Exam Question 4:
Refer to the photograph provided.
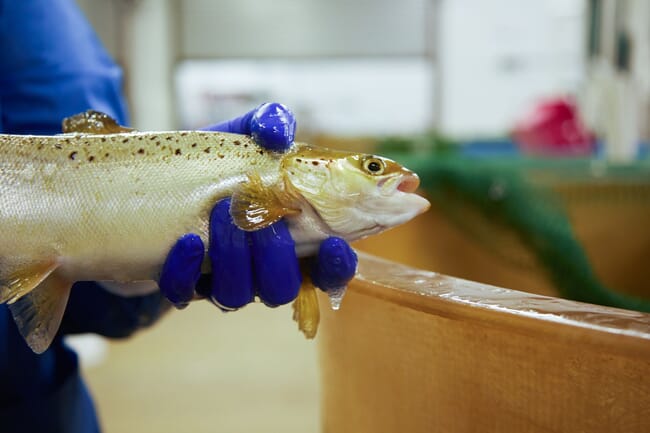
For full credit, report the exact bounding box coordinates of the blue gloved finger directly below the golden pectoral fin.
[250,220,302,307]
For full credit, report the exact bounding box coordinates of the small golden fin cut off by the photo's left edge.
[0,260,58,304]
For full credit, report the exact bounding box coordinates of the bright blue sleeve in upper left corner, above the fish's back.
[0,0,127,134]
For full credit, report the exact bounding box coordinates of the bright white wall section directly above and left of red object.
[440,0,584,135]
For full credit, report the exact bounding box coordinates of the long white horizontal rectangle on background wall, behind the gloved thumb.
[176,57,433,136]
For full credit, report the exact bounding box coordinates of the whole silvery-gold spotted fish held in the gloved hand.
[0,110,429,353]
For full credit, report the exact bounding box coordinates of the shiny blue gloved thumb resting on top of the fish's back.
[202,102,296,152]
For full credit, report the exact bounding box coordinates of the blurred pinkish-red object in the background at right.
[512,98,596,156]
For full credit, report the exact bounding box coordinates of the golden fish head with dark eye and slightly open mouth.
[282,145,430,241]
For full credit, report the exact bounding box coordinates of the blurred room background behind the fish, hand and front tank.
[69,0,650,432]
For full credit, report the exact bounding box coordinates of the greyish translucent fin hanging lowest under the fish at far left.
[9,272,72,353]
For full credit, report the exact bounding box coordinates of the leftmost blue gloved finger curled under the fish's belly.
[158,233,204,308]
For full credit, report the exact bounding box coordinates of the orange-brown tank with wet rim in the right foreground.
[319,255,650,433]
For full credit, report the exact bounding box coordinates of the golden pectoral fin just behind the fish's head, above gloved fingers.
[230,173,300,231]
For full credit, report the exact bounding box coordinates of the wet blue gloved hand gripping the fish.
[159,103,357,310]
